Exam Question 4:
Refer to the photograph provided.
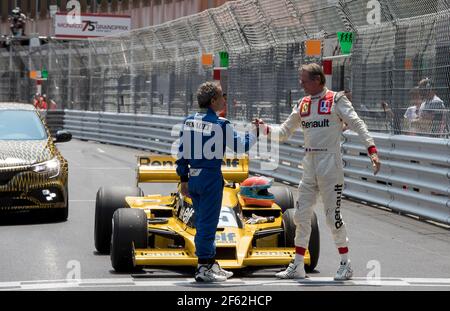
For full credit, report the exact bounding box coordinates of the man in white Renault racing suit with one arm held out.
[255,64,380,280]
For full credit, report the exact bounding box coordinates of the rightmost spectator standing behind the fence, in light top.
[418,78,446,137]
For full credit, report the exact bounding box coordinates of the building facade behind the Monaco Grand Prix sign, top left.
[0,0,227,36]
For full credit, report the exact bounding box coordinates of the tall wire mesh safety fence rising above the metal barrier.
[0,0,450,137]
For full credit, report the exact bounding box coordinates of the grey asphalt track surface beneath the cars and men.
[0,140,450,293]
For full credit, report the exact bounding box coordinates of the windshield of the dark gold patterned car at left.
[0,110,47,140]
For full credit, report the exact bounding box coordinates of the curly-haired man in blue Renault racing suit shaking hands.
[176,82,257,282]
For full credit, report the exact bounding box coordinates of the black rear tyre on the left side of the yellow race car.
[94,186,144,254]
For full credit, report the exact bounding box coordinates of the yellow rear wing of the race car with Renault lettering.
[137,155,248,184]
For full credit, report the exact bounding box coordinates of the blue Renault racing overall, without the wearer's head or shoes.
[176,108,256,260]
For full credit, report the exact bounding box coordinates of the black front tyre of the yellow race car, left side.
[111,208,148,272]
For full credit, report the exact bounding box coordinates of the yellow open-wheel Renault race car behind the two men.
[94,156,320,272]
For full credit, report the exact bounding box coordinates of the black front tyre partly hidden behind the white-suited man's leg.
[280,209,320,272]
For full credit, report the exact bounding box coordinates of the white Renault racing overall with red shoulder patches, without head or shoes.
[270,88,376,252]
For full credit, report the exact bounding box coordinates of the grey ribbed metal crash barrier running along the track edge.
[48,110,450,224]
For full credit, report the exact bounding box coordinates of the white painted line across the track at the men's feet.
[0,277,450,291]
